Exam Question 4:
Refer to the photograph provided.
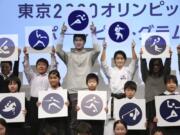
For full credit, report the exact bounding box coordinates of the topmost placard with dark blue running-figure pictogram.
[65,7,92,34]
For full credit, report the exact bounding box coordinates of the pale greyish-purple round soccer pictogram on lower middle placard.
[81,94,103,116]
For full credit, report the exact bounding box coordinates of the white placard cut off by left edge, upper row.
[0,34,18,61]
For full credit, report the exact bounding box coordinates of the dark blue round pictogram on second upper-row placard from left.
[28,29,49,50]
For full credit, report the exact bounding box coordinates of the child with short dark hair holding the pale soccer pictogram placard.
[77,73,107,135]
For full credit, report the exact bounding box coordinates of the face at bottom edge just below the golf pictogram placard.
[114,123,127,135]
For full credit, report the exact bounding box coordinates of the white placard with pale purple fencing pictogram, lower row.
[38,89,68,118]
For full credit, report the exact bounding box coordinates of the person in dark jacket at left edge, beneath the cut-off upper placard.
[0,49,21,93]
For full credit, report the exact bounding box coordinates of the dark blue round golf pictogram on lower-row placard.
[119,103,142,126]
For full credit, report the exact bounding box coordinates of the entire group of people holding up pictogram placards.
[0,24,180,135]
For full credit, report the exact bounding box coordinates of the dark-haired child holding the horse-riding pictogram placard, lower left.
[7,76,27,135]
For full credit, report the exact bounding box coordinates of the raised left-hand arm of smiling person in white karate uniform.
[101,41,110,78]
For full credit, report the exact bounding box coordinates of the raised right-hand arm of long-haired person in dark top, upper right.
[163,50,172,76]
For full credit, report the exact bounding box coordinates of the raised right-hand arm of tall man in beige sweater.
[90,23,100,65]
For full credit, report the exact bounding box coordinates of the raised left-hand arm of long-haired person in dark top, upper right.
[140,49,149,83]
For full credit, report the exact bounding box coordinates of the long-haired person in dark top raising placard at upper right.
[140,50,172,132]
